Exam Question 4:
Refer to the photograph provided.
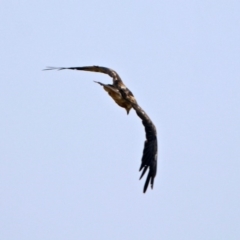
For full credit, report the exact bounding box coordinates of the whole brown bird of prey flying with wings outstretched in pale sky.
[44,66,157,193]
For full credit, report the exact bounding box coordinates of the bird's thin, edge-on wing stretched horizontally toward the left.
[44,66,122,82]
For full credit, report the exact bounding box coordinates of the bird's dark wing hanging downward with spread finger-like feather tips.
[133,104,157,193]
